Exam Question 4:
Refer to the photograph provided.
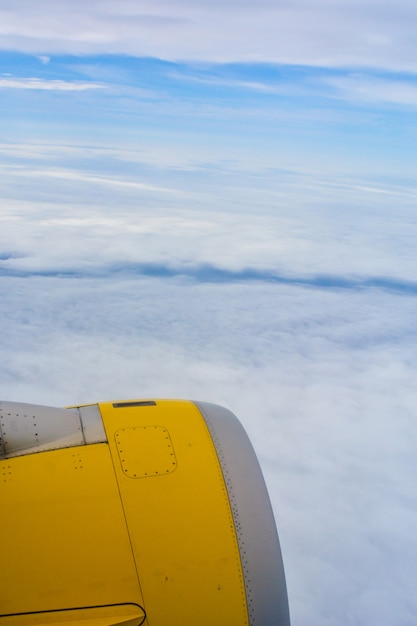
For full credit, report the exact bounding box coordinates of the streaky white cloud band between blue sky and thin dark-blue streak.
[0,144,417,282]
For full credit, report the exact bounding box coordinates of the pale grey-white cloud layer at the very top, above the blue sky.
[0,0,415,71]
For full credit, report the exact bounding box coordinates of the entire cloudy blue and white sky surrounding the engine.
[0,0,417,626]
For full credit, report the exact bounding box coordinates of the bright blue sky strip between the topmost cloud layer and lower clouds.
[0,52,417,176]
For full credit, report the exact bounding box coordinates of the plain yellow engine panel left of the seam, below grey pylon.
[0,443,143,626]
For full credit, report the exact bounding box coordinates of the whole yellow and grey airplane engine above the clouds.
[0,399,290,626]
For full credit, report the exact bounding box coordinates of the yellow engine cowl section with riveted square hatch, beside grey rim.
[99,401,249,626]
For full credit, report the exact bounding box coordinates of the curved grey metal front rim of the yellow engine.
[194,402,290,626]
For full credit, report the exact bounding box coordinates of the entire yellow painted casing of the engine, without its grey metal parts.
[0,401,249,626]
